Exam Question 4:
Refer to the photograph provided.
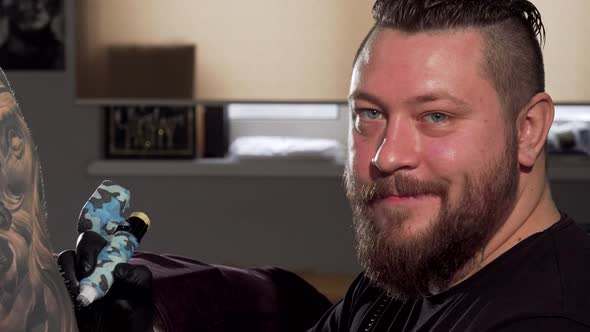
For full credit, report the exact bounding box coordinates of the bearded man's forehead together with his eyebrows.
[349,25,498,113]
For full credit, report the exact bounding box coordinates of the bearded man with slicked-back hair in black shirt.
[314,0,590,331]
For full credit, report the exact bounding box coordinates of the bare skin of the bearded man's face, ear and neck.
[348,28,559,282]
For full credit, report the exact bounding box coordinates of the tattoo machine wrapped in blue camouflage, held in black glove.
[77,180,150,306]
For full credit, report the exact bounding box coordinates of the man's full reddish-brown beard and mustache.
[344,137,518,299]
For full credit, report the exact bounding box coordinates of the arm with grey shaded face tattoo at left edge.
[0,69,77,332]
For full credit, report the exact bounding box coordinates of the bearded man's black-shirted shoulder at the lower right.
[430,218,590,331]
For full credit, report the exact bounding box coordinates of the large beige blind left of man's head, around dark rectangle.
[77,0,372,100]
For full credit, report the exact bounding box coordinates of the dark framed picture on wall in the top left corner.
[0,0,65,70]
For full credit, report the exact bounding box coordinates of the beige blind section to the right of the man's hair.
[533,0,590,103]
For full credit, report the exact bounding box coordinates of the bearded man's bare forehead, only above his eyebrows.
[351,28,483,93]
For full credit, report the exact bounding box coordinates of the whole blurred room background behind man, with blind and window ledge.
[0,0,590,298]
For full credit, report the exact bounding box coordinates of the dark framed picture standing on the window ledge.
[103,105,196,159]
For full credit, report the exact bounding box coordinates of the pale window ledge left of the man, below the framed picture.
[88,158,344,178]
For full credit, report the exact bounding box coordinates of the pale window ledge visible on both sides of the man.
[88,155,590,180]
